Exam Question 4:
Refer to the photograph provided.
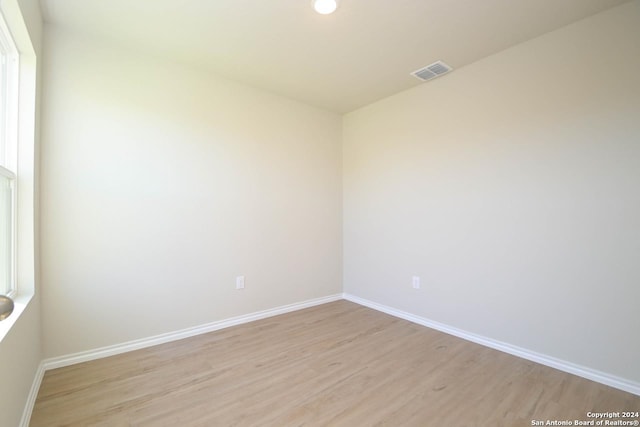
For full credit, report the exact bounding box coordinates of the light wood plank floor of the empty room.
[31,301,640,427]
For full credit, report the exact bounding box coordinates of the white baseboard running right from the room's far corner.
[343,293,640,396]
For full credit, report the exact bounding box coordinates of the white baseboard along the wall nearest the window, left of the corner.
[42,294,342,372]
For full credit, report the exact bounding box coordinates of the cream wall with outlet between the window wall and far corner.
[41,27,342,357]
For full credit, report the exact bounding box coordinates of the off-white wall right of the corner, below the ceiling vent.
[343,1,640,381]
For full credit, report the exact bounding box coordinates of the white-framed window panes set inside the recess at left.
[0,10,19,296]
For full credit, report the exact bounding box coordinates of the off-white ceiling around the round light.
[41,0,627,113]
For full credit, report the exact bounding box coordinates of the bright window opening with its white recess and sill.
[0,0,36,340]
